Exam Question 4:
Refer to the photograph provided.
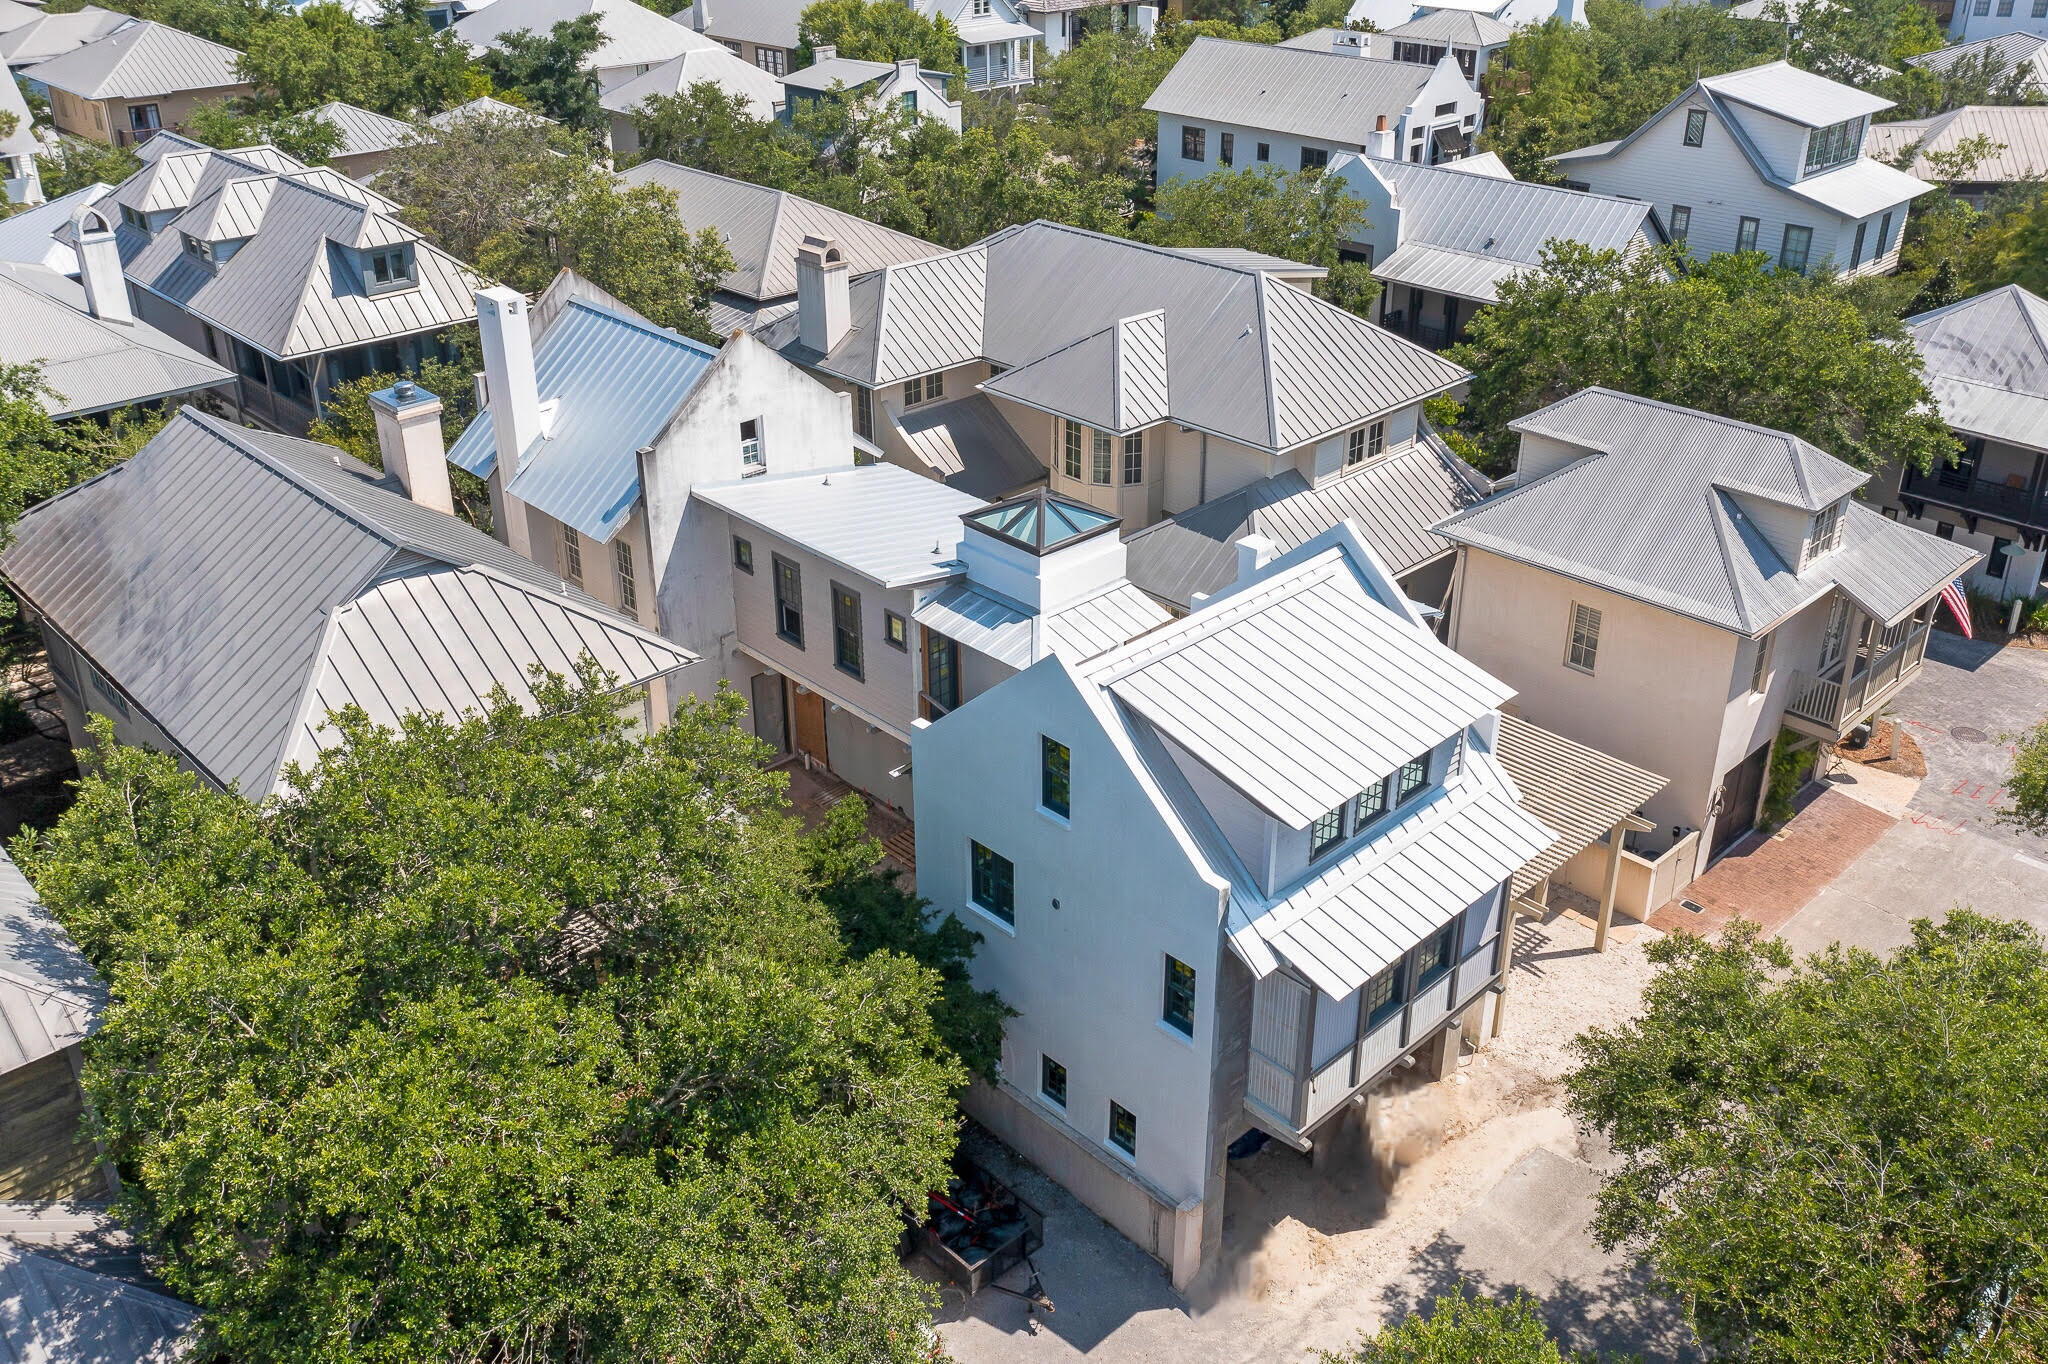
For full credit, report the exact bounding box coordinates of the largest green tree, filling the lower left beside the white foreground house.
[20,670,963,1364]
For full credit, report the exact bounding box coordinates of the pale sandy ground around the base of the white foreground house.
[940,897,1657,1364]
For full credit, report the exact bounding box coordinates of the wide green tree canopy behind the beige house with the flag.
[1446,242,1956,473]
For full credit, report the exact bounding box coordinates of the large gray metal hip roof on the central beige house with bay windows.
[762,219,1470,451]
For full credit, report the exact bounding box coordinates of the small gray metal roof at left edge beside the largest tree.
[0,848,106,1075]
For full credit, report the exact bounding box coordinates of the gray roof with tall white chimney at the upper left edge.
[0,207,236,420]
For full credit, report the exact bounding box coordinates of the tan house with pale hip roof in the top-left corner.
[27,18,254,147]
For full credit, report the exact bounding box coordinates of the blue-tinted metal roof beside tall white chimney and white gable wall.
[449,299,719,543]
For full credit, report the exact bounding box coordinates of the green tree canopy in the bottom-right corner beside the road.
[1567,909,2048,1364]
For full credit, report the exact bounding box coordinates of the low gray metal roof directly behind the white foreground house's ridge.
[1124,440,1487,608]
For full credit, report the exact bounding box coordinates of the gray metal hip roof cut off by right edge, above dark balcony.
[1907,285,2048,451]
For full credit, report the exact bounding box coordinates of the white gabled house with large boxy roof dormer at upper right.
[1550,61,1929,276]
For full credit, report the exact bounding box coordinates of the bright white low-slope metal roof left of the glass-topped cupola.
[690,465,981,588]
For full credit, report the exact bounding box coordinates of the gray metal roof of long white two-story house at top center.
[1145,37,1436,145]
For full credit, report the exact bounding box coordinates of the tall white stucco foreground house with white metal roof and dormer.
[911,524,1554,1290]
